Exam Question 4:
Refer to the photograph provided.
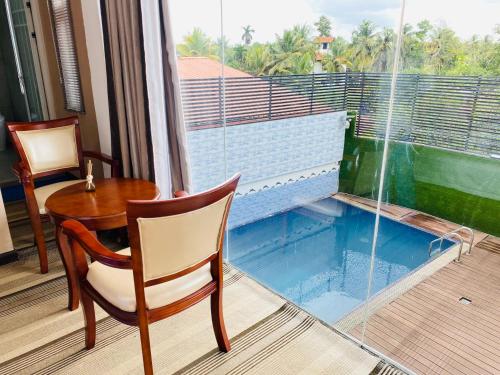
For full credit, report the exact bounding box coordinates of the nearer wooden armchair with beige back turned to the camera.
[62,175,240,374]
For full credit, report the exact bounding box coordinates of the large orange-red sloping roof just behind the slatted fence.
[177,57,330,130]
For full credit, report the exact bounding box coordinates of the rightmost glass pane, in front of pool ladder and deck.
[360,0,500,374]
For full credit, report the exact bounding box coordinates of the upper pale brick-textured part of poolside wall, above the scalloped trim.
[188,112,346,191]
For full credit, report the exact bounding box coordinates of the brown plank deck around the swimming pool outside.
[336,195,500,375]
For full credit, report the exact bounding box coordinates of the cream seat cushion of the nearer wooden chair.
[87,248,212,312]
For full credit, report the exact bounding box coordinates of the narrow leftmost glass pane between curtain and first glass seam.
[171,0,227,192]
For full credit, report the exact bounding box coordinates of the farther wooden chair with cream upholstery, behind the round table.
[7,117,119,273]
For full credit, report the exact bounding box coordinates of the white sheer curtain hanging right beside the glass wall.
[141,0,191,198]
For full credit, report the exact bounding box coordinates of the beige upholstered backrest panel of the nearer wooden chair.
[137,193,233,281]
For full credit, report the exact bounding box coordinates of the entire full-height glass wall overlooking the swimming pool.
[166,0,500,373]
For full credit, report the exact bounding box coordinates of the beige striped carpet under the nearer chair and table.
[0,267,379,375]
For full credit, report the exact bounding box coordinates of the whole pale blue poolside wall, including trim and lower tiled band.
[188,112,346,227]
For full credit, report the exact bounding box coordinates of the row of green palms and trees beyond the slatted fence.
[177,20,500,76]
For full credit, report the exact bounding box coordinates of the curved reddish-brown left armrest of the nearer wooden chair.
[61,220,132,269]
